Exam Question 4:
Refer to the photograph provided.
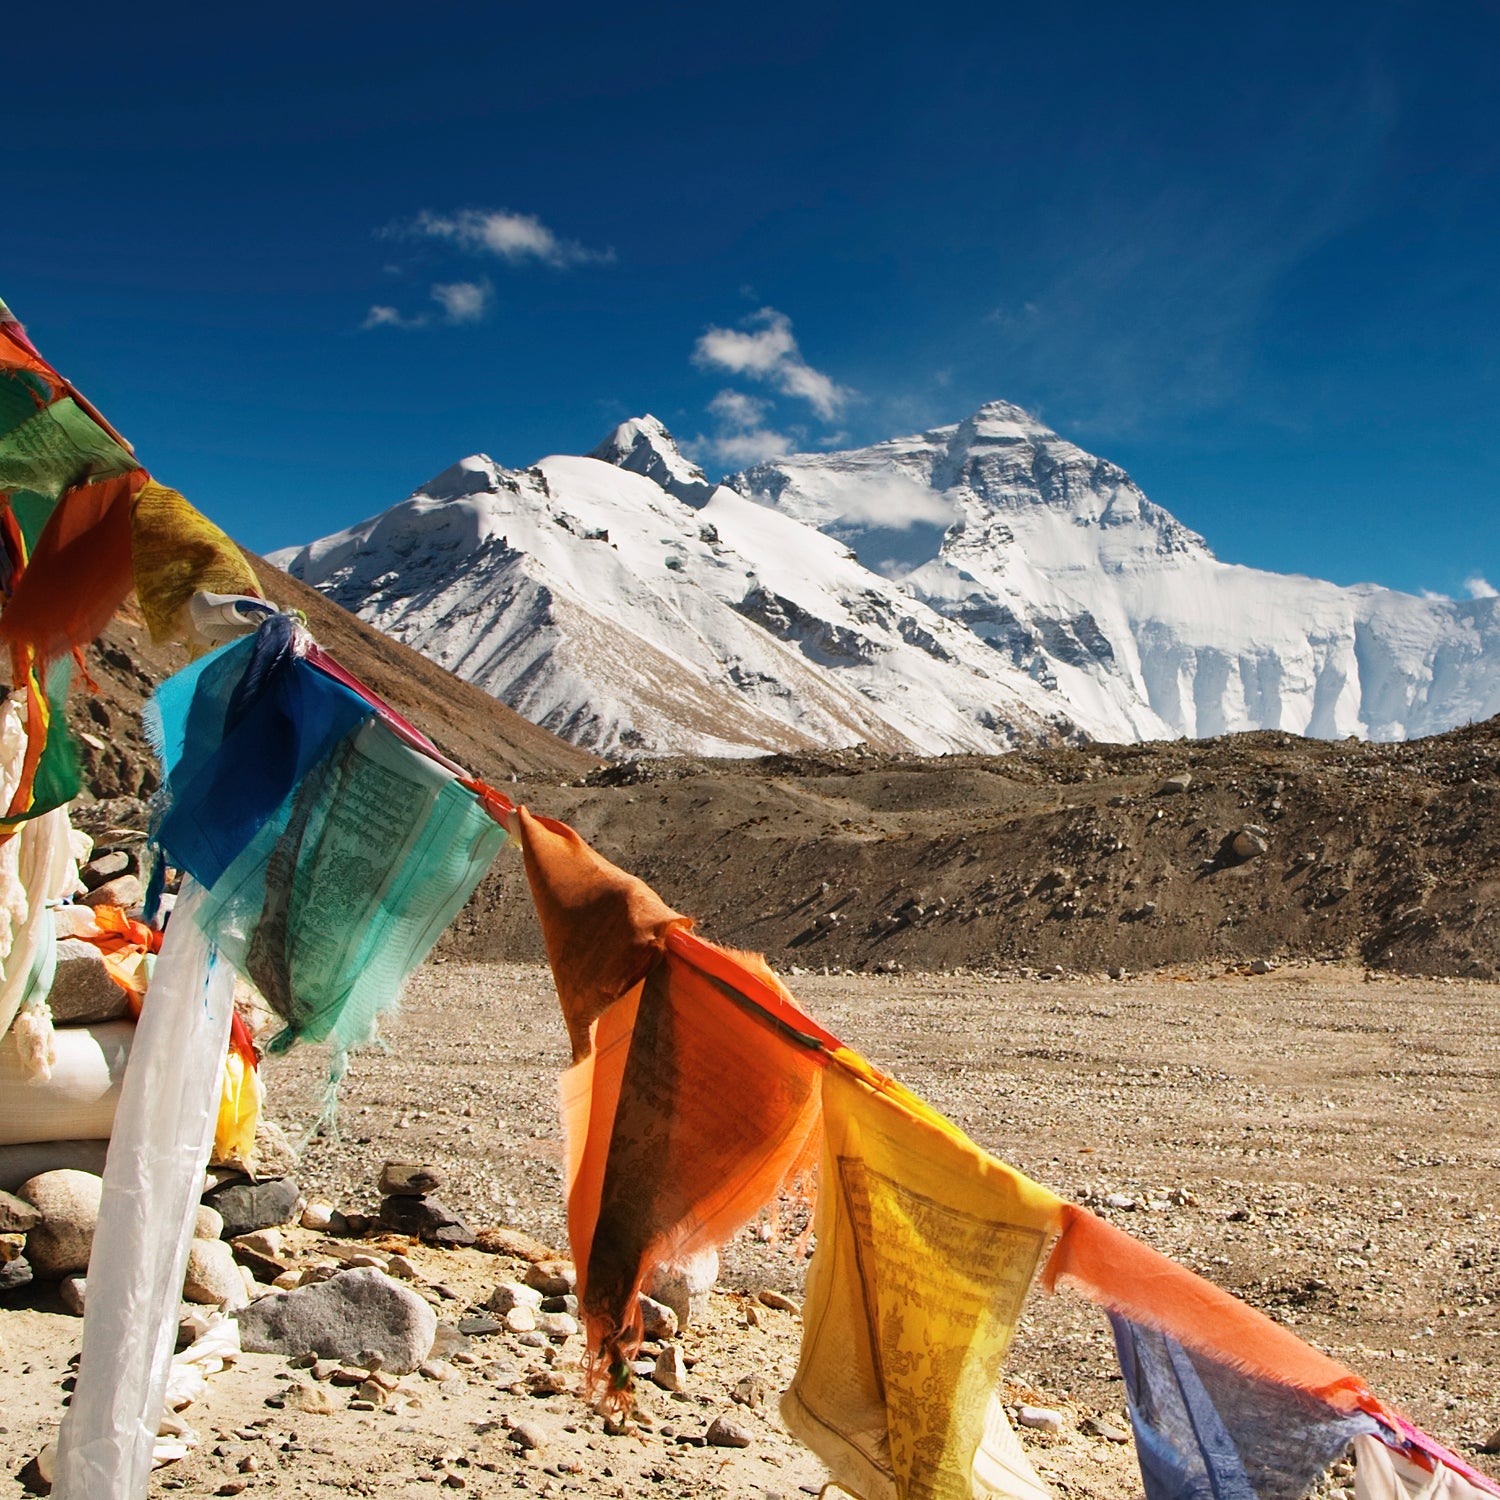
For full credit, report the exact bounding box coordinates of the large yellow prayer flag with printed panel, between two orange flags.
[782,1050,1062,1500]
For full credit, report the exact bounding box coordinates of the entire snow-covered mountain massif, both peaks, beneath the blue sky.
[272,402,1500,755]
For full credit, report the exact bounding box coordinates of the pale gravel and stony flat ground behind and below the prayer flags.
[0,962,1500,1500]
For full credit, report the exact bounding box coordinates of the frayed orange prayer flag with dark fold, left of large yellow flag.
[518,809,836,1404]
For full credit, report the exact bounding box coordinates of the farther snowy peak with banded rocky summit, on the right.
[726,402,1500,740]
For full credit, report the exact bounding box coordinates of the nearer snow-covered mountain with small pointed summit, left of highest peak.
[276,438,1073,755]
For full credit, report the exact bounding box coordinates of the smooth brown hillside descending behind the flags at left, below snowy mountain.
[68,557,599,822]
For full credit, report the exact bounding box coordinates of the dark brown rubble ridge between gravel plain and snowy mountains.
[447,720,1500,978]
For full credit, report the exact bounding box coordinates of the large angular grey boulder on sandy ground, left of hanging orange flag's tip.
[240,1269,435,1374]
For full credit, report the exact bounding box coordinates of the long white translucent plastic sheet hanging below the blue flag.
[53,881,234,1500]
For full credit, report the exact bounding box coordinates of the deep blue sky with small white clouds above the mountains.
[0,0,1500,594]
